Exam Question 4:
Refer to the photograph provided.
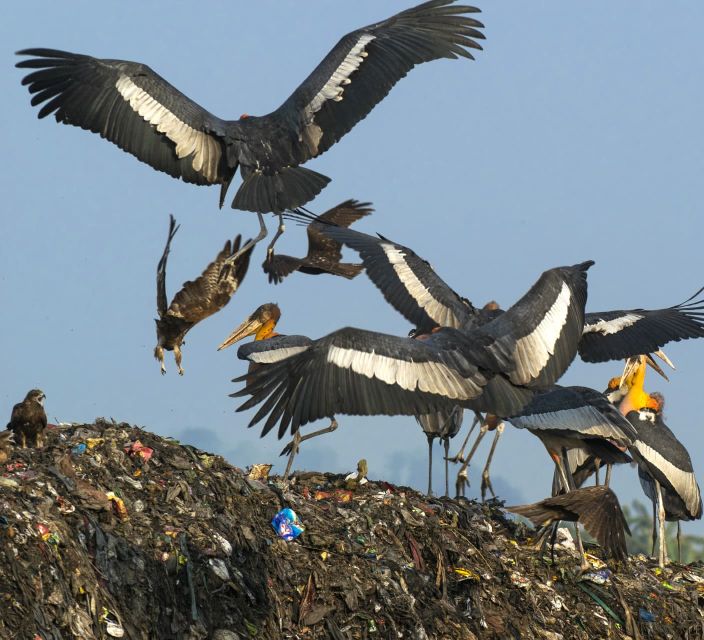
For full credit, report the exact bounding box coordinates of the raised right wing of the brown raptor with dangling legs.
[167,235,254,324]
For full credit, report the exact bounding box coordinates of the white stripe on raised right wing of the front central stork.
[511,282,571,384]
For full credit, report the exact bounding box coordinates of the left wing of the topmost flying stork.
[16,49,231,184]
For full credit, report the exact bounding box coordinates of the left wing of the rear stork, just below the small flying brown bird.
[321,226,476,331]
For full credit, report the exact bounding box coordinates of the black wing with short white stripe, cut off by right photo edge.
[579,288,704,362]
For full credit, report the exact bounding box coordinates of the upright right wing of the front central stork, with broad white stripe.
[470,261,594,389]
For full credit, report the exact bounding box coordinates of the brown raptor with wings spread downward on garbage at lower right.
[506,485,631,561]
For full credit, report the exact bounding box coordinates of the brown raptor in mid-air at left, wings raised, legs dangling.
[154,216,254,375]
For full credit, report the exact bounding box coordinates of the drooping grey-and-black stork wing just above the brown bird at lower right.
[507,386,637,445]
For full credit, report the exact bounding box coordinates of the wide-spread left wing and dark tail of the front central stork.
[232,328,532,437]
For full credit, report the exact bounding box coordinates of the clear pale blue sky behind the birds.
[0,0,704,533]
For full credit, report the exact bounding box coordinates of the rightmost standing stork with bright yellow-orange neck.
[619,358,702,566]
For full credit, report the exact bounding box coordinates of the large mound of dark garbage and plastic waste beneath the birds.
[0,420,704,640]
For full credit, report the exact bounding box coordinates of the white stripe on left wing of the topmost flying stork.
[115,75,221,182]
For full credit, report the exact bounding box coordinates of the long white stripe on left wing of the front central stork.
[327,345,482,400]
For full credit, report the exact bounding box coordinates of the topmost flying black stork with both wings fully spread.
[17,0,484,258]
